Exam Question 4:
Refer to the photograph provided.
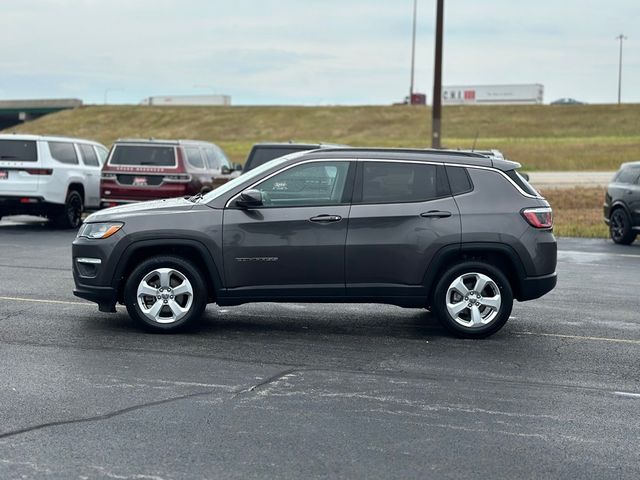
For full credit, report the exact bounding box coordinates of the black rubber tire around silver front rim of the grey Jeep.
[124,255,208,333]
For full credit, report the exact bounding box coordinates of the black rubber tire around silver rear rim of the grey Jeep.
[431,261,513,338]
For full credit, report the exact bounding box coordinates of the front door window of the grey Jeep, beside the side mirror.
[256,162,349,207]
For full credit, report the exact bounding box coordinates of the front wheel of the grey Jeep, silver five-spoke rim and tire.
[124,256,207,332]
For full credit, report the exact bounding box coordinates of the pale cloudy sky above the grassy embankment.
[0,0,640,105]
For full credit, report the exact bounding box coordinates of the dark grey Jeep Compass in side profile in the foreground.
[73,148,556,337]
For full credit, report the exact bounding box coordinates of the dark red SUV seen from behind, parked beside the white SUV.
[100,139,239,207]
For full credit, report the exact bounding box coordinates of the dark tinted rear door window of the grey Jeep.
[362,162,449,203]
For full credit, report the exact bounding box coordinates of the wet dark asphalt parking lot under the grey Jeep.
[0,219,640,479]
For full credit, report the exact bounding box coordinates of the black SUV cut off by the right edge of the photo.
[604,162,640,245]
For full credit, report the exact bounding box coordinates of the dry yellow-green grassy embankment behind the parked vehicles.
[2,105,640,170]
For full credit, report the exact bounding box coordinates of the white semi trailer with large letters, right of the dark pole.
[442,83,544,105]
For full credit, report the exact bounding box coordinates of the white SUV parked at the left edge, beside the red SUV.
[0,134,108,228]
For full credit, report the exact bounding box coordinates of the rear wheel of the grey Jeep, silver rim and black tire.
[432,262,513,338]
